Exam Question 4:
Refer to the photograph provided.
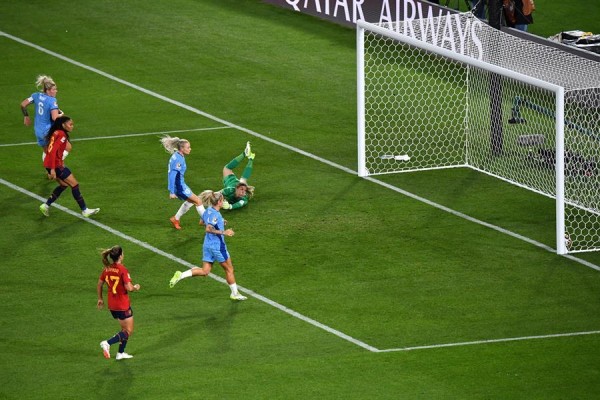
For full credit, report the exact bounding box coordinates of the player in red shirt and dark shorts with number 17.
[97,246,140,360]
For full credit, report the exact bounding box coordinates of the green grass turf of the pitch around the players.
[0,0,600,399]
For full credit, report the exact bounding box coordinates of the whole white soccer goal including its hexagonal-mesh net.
[357,13,600,254]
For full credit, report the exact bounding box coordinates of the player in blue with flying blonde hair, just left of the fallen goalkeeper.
[160,135,205,230]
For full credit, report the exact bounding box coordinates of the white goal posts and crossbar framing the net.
[356,21,568,254]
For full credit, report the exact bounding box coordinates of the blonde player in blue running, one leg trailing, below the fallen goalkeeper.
[169,190,247,300]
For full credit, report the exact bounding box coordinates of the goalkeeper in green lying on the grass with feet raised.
[221,142,255,210]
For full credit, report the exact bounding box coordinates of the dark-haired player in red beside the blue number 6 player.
[40,115,100,218]
